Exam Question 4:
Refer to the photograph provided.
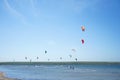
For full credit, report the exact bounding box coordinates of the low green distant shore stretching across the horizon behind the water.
[0,61,120,65]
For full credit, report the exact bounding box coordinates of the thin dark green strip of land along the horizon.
[0,62,120,65]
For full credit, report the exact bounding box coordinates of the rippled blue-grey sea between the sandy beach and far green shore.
[0,63,120,80]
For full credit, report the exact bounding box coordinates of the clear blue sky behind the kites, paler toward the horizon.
[0,0,120,62]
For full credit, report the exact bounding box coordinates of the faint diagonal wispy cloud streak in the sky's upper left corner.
[4,0,27,24]
